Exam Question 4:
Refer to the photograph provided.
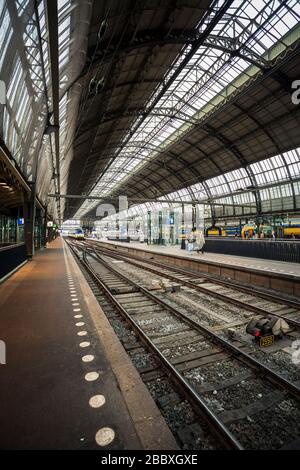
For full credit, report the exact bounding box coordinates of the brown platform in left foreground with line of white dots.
[0,239,177,450]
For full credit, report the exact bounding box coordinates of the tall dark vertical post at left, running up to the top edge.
[46,0,62,222]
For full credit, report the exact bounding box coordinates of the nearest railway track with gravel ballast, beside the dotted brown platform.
[68,244,300,449]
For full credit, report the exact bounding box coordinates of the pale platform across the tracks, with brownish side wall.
[93,239,300,297]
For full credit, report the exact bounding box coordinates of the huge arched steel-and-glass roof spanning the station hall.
[0,0,300,219]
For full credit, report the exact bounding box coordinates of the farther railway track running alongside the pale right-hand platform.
[82,242,300,328]
